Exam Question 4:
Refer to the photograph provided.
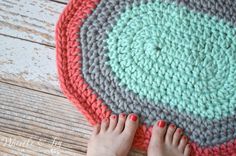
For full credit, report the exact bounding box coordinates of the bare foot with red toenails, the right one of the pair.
[148,120,190,156]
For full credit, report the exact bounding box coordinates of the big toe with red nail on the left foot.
[123,114,138,137]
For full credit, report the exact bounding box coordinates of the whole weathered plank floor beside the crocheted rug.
[0,0,145,156]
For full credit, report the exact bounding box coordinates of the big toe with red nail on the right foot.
[150,120,167,146]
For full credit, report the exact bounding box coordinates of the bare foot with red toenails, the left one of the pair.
[87,114,138,156]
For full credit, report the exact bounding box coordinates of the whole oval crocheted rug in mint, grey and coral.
[56,0,236,156]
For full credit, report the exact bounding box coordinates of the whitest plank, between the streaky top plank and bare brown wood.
[0,35,62,96]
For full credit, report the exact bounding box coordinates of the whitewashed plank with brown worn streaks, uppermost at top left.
[0,0,66,46]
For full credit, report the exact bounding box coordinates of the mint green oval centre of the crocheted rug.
[106,1,236,119]
